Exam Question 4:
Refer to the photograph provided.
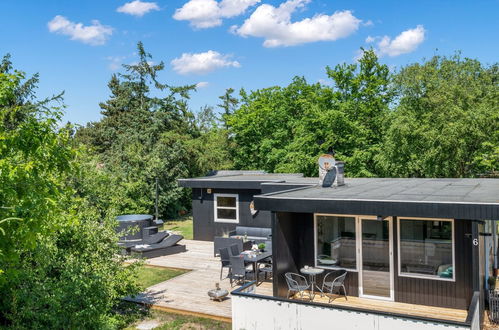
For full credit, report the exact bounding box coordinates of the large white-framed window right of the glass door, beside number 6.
[398,218,455,280]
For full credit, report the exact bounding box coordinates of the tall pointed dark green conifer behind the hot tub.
[77,42,199,217]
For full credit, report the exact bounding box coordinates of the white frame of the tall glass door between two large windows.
[357,216,395,301]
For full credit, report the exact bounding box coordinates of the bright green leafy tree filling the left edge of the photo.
[0,56,139,329]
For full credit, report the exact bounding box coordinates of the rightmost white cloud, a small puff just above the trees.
[378,25,426,56]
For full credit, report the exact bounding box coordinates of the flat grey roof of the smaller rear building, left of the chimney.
[178,171,318,189]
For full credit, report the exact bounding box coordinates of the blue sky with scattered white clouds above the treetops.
[0,0,499,124]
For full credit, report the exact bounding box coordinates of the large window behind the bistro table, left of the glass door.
[315,215,357,270]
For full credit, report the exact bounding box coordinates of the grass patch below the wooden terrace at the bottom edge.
[122,304,231,330]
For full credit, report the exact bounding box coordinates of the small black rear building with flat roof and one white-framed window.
[178,171,317,241]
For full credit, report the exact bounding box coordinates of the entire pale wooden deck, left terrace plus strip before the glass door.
[130,240,467,322]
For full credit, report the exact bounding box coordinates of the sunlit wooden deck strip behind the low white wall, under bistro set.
[256,283,468,322]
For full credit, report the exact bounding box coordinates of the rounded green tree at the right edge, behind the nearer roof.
[379,53,499,177]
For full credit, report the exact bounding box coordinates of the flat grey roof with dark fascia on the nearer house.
[255,178,499,220]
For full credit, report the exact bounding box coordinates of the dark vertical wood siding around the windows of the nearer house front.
[272,212,473,309]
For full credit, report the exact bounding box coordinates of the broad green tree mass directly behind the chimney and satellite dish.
[228,50,391,176]
